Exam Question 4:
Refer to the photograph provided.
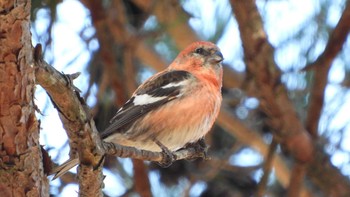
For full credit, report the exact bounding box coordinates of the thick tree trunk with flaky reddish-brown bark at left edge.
[0,0,49,197]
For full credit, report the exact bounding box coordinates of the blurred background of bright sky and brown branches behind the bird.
[31,0,350,196]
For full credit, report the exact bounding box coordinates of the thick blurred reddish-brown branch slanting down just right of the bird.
[230,0,313,196]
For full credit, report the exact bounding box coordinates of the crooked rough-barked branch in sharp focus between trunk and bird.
[34,45,104,196]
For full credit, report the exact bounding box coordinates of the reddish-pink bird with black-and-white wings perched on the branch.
[52,41,224,179]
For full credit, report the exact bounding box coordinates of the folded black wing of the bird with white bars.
[101,70,194,138]
